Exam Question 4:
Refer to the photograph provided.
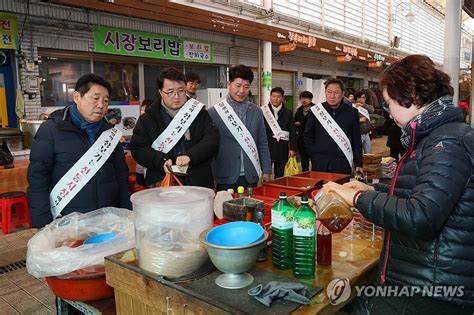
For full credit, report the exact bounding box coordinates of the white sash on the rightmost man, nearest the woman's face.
[311,103,354,168]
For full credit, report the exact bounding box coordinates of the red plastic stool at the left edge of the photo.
[0,191,31,234]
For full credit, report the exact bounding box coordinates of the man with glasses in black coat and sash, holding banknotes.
[130,68,219,188]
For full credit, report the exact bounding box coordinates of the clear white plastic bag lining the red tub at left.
[26,207,135,278]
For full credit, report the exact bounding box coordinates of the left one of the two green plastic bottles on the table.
[272,192,295,270]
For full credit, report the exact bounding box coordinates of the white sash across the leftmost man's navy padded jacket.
[49,128,122,218]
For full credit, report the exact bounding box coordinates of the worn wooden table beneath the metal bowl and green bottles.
[105,230,383,314]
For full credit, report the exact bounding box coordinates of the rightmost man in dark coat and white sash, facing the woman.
[304,78,362,174]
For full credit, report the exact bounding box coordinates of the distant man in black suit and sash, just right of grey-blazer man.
[265,87,296,178]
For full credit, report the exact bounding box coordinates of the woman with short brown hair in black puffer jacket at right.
[324,55,474,314]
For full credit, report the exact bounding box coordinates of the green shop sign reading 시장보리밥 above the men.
[94,26,214,63]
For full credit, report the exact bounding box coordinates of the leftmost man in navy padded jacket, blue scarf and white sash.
[27,74,132,228]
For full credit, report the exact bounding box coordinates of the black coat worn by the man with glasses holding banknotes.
[130,99,219,188]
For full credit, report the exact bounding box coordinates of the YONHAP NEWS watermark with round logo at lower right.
[326,278,464,305]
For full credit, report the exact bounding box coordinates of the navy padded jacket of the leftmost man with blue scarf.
[28,107,132,228]
